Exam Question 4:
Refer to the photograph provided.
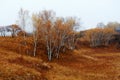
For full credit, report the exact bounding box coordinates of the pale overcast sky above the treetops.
[0,0,120,28]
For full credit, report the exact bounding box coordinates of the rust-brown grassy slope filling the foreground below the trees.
[0,38,120,80]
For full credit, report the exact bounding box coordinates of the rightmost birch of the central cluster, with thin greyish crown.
[66,17,80,50]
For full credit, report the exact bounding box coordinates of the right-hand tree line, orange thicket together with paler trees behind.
[83,22,120,47]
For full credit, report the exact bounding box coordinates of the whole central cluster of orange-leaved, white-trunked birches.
[32,10,79,61]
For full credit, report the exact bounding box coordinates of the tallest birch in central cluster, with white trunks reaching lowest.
[40,11,56,61]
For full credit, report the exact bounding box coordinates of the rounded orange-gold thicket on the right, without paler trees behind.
[84,28,115,46]
